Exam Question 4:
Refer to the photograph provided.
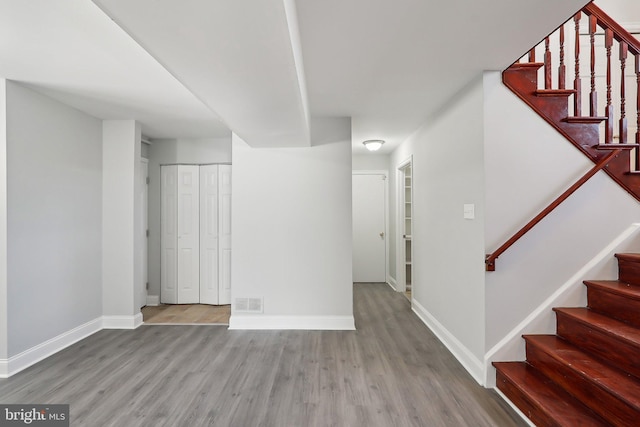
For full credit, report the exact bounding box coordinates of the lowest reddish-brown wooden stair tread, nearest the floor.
[493,362,608,426]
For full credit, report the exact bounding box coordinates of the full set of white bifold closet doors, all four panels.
[160,165,231,305]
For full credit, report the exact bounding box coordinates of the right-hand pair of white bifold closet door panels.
[200,165,231,305]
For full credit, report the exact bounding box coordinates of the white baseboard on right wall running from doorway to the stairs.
[411,298,484,385]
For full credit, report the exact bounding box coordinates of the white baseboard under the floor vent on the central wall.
[229,314,356,331]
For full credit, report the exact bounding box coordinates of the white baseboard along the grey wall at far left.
[0,317,102,378]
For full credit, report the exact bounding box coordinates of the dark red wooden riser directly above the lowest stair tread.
[527,341,638,427]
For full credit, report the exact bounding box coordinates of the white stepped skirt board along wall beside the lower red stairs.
[484,223,640,388]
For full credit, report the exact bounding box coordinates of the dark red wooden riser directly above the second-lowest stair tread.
[556,312,640,377]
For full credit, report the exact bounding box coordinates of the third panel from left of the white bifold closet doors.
[200,165,218,304]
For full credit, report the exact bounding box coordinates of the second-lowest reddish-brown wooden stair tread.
[524,335,640,413]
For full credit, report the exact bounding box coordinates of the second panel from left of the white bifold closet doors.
[177,165,200,304]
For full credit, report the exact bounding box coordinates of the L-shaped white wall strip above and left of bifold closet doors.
[148,136,231,295]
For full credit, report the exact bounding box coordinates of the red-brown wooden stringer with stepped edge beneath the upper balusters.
[502,63,640,201]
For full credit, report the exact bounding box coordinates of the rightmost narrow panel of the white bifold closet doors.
[218,165,231,304]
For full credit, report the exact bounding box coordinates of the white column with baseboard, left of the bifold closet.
[102,120,142,329]
